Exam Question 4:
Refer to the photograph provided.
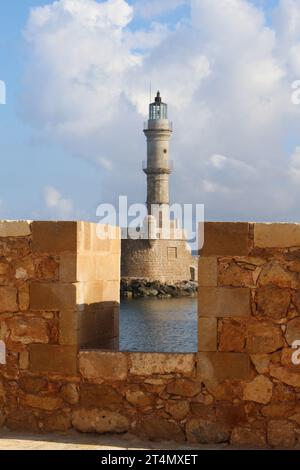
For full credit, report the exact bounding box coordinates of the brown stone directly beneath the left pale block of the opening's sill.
[80,384,123,409]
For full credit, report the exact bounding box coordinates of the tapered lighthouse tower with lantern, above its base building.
[144,91,172,219]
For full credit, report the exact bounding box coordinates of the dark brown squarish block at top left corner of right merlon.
[200,222,249,256]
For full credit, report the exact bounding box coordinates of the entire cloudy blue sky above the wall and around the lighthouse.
[0,0,300,221]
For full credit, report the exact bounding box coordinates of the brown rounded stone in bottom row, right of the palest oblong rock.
[134,415,185,442]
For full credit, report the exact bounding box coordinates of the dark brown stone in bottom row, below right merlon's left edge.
[186,418,230,444]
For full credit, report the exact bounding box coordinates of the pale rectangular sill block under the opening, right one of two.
[129,353,195,376]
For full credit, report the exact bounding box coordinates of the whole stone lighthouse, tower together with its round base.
[121,92,197,284]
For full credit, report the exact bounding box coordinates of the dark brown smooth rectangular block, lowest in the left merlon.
[29,344,77,375]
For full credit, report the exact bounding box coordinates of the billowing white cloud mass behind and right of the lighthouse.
[24,0,300,219]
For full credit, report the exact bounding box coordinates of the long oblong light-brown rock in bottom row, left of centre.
[72,408,129,434]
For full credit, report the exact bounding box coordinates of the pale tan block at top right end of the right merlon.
[254,223,300,248]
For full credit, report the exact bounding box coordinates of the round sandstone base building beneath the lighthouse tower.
[121,239,198,283]
